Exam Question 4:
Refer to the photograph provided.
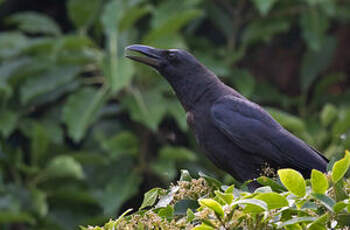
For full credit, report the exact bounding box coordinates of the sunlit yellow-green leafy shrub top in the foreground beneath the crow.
[85,152,350,230]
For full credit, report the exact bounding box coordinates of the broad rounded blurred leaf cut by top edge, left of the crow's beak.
[67,0,100,28]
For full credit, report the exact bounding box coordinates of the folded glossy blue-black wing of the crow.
[211,96,327,171]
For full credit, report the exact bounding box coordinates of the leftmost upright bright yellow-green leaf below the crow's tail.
[277,169,306,197]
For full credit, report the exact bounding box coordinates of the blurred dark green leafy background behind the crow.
[0,0,350,230]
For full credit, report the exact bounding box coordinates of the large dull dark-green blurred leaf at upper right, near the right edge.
[300,37,336,92]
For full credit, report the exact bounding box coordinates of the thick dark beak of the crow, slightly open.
[125,45,161,68]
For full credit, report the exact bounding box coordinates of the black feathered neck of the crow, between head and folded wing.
[167,71,225,111]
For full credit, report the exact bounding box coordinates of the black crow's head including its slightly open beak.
[125,45,206,80]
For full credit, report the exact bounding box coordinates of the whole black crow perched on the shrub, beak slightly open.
[125,45,328,191]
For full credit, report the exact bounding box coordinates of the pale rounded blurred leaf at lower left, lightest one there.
[45,155,84,179]
